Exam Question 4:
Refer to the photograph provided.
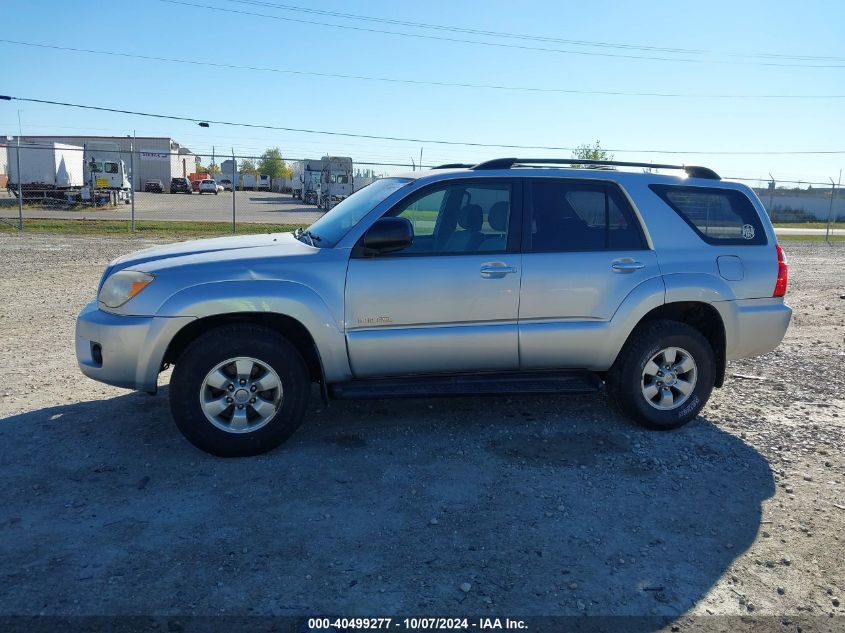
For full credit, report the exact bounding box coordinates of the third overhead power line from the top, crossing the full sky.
[0,38,845,99]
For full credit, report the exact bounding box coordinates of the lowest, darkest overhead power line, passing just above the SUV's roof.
[0,95,845,156]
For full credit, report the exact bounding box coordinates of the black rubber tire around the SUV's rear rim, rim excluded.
[608,320,716,431]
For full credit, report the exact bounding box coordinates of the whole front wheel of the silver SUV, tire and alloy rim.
[170,325,311,457]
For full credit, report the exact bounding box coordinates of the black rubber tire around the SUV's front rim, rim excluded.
[170,325,311,457]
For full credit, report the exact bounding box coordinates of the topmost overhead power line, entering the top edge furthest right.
[225,0,845,61]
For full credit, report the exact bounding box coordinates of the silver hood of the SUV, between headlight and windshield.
[106,233,314,276]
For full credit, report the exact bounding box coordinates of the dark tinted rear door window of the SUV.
[526,180,646,252]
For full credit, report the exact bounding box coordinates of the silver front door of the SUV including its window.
[345,179,521,377]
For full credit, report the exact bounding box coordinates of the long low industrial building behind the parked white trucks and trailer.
[0,134,197,191]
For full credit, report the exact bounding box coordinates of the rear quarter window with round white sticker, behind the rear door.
[649,185,767,245]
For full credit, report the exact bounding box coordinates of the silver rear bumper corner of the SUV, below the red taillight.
[722,297,792,360]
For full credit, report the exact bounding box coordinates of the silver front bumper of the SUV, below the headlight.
[76,301,193,393]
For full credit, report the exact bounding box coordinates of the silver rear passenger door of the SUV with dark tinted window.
[519,178,660,369]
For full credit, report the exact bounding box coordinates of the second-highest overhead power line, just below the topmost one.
[159,0,845,68]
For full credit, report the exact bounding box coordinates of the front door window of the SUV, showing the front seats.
[389,182,511,254]
